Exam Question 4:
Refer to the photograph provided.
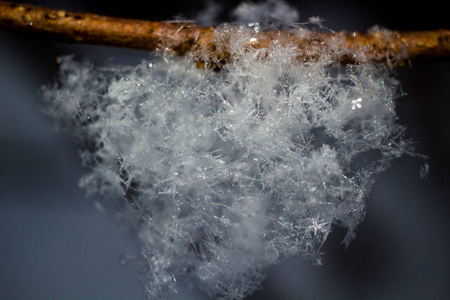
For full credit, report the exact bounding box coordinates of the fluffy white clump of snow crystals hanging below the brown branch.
[43,1,409,299]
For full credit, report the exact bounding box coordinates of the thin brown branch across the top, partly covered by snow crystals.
[0,1,450,65]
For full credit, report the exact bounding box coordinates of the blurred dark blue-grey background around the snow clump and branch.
[0,0,450,300]
